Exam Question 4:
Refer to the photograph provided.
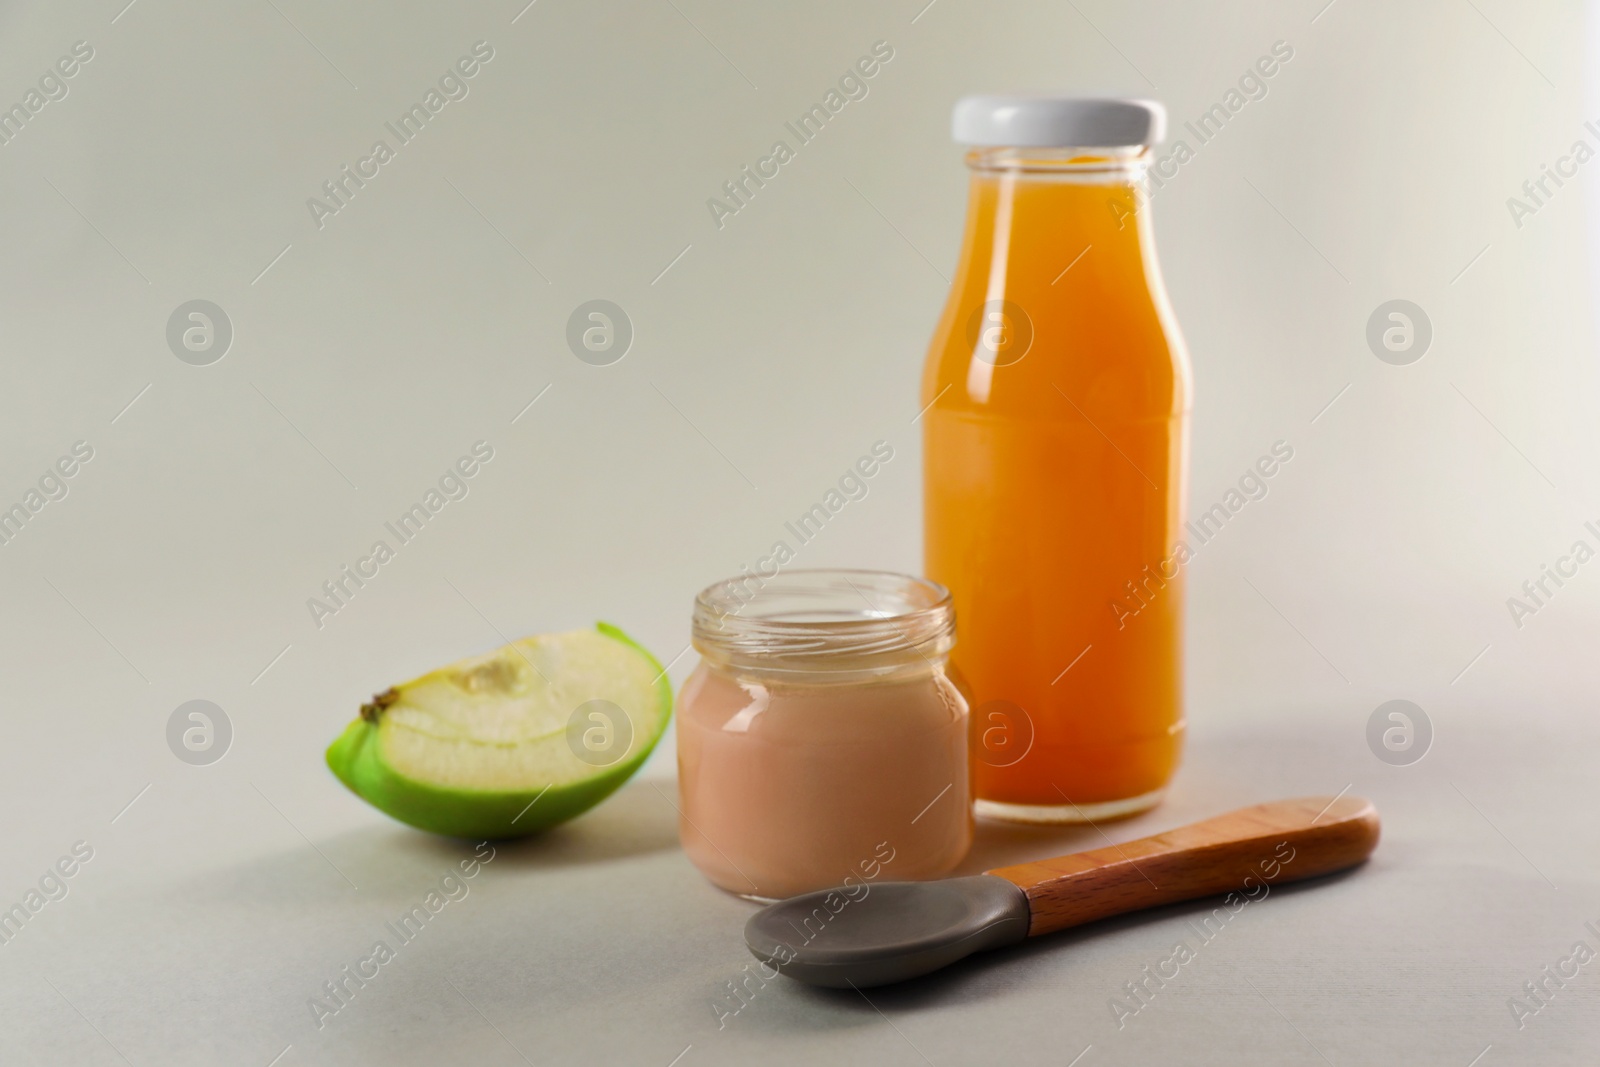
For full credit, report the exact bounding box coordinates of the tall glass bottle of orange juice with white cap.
[920,96,1190,822]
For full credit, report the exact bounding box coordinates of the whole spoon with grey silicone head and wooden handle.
[744,797,1379,987]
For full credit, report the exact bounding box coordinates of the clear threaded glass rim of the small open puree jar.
[693,568,955,672]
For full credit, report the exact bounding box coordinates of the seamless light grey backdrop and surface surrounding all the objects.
[0,0,1600,1067]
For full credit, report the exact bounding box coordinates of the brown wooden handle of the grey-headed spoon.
[987,797,1378,937]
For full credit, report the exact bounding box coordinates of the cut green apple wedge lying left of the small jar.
[328,622,672,840]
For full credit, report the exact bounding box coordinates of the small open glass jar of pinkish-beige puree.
[677,571,973,899]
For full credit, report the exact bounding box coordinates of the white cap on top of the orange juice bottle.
[950,96,1166,149]
